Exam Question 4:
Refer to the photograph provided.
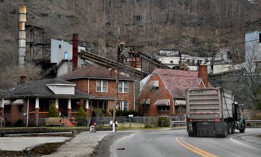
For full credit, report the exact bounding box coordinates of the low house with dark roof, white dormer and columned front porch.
[0,79,90,126]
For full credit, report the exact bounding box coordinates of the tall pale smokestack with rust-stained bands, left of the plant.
[18,4,26,66]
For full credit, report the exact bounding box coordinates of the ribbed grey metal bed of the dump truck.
[186,88,233,120]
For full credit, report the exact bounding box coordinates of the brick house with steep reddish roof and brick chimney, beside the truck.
[138,65,208,116]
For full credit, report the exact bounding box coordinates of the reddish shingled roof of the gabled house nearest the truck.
[152,69,204,98]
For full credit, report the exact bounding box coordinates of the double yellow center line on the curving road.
[176,137,217,157]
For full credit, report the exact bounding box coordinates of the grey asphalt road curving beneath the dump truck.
[99,128,261,157]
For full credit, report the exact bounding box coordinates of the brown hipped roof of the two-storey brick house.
[59,65,133,81]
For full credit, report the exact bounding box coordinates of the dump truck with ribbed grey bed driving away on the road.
[186,87,246,137]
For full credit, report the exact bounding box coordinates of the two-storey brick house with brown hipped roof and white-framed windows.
[60,65,135,115]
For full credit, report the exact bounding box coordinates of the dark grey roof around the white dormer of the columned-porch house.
[7,79,90,99]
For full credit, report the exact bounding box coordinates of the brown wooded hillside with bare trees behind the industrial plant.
[0,0,261,86]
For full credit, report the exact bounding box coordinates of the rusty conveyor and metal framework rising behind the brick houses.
[79,47,169,80]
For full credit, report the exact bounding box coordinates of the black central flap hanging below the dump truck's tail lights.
[197,122,215,137]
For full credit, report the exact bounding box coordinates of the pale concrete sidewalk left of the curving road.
[44,131,113,157]
